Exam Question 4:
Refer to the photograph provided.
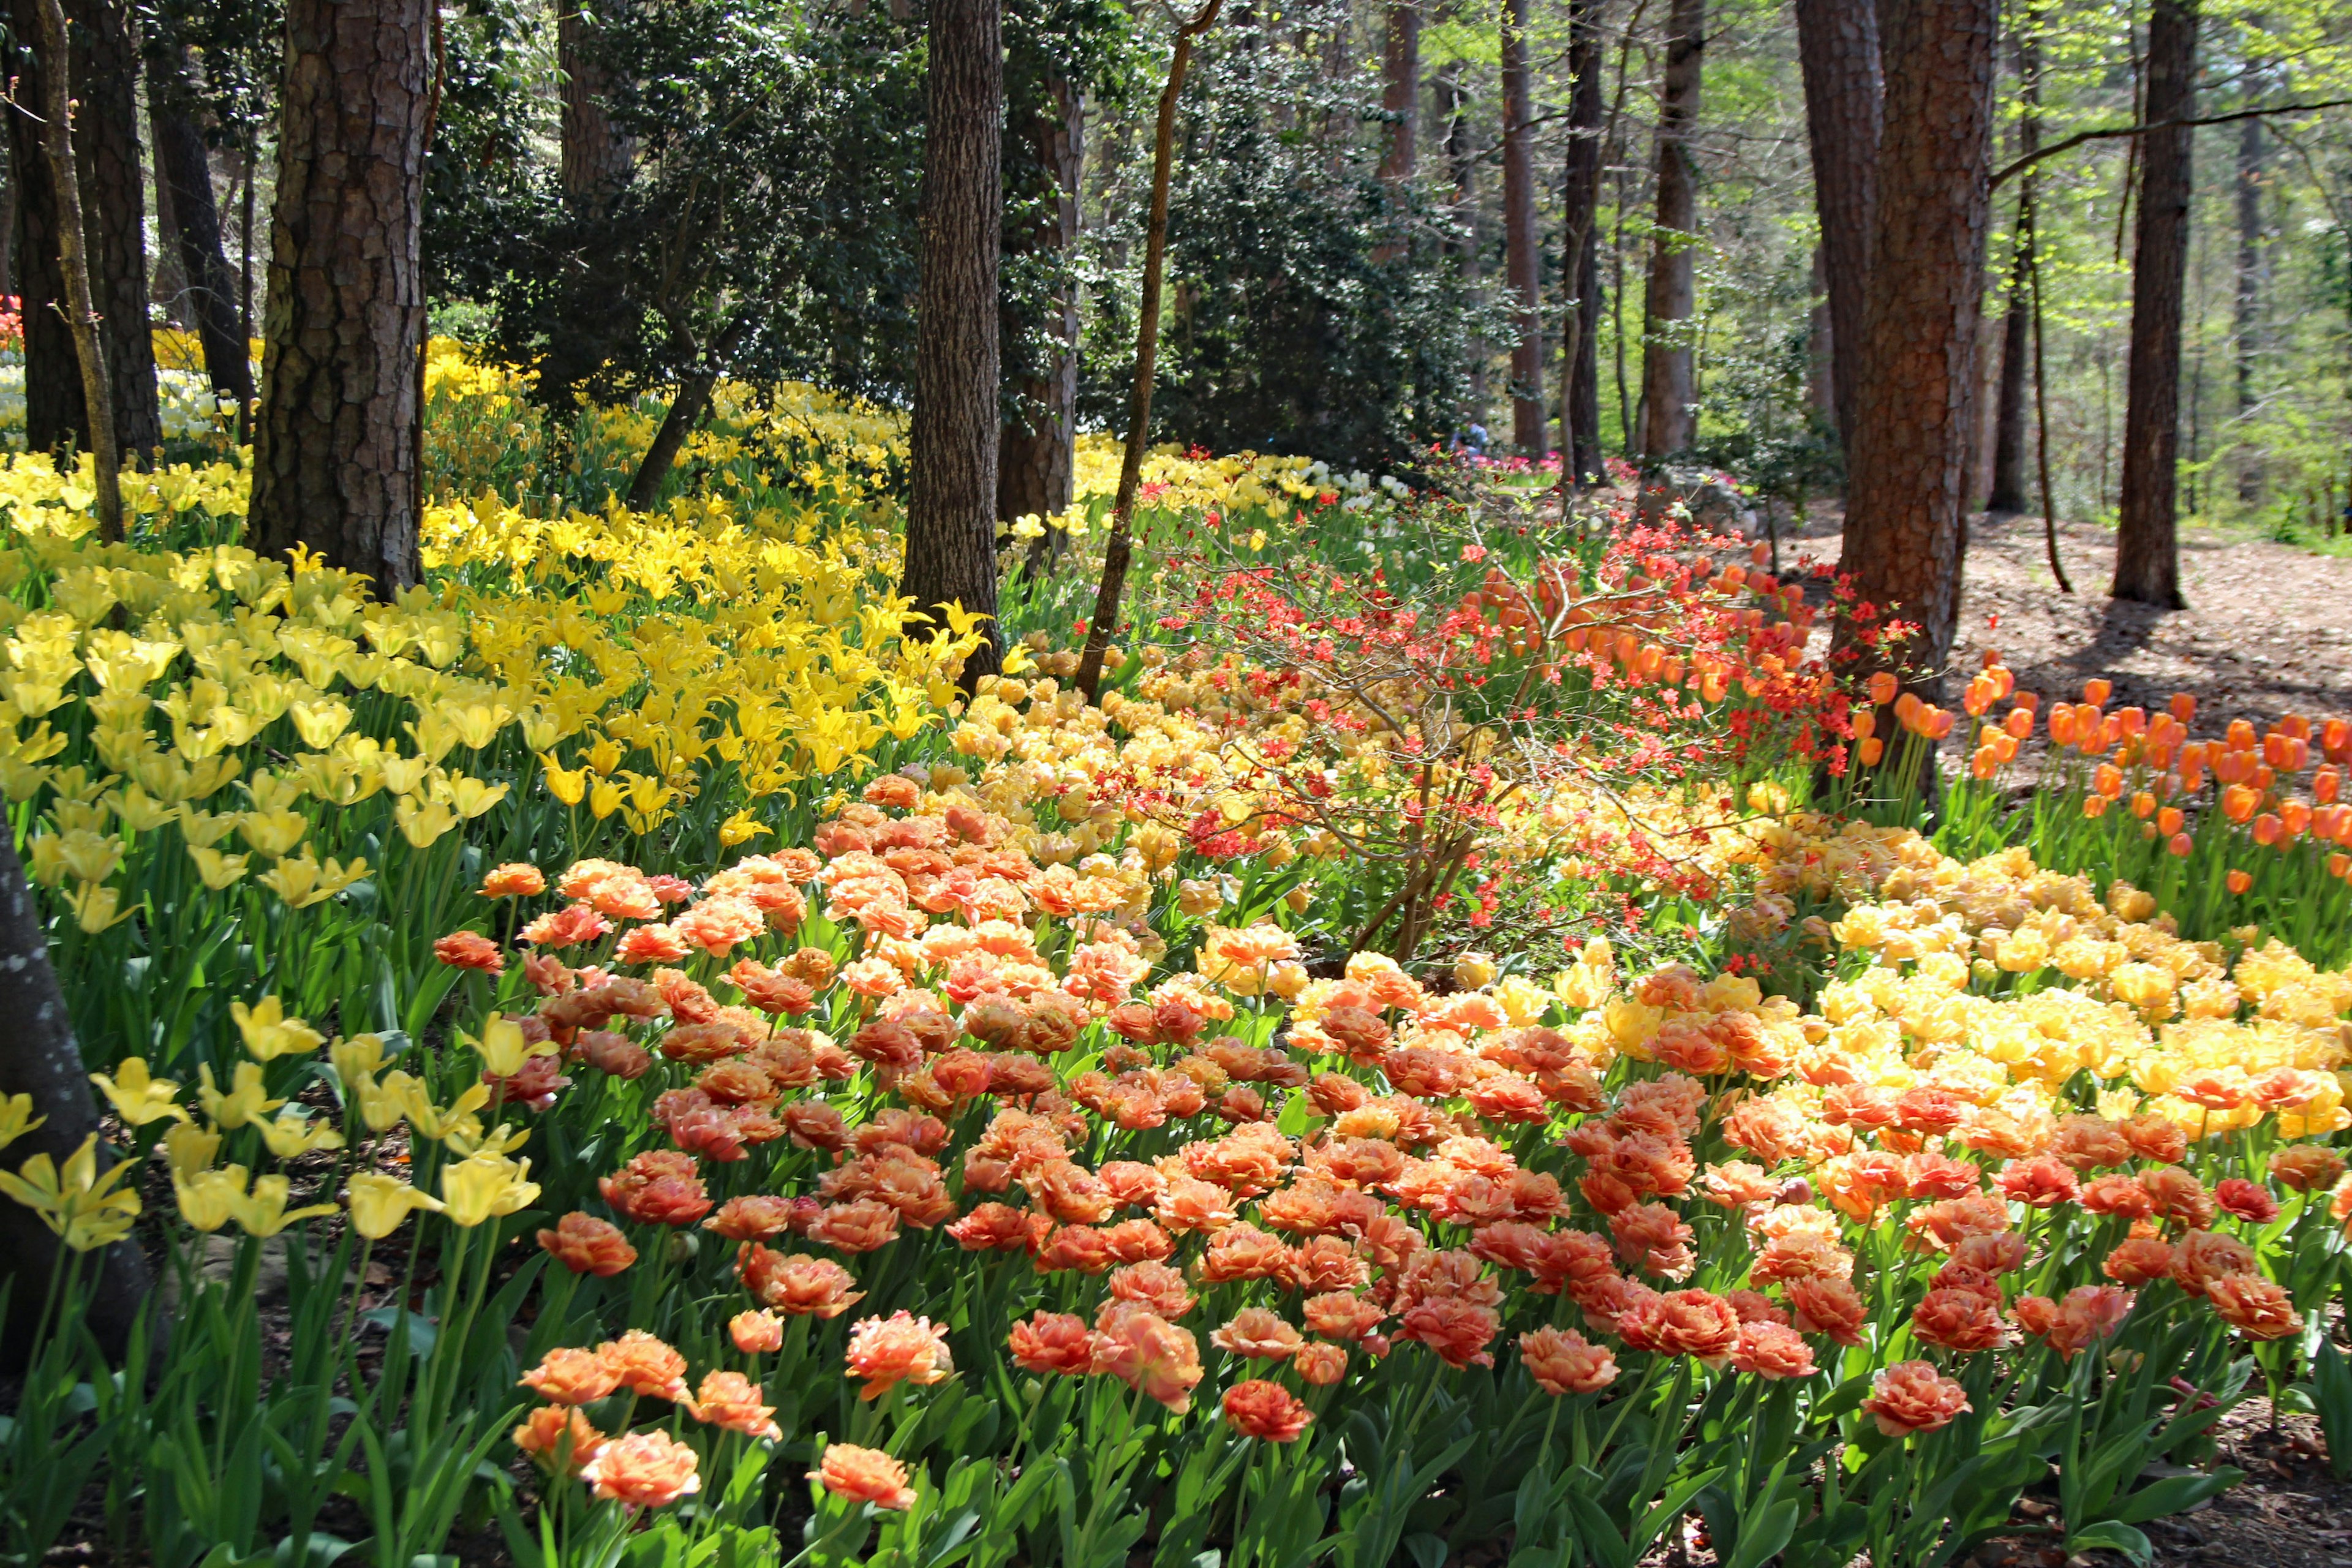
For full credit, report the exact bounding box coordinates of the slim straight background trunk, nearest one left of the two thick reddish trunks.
[1642,0,1708,463]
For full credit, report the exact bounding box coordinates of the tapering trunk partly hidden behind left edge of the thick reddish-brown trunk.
[1797,0,1884,458]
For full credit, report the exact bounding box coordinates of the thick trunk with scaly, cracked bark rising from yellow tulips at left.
[249,0,431,597]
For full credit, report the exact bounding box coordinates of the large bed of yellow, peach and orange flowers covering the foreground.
[0,362,2352,1568]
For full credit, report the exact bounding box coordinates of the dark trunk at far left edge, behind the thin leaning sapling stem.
[9,0,162,454]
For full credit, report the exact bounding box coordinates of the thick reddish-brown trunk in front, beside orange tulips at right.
[1839,0,1999,698]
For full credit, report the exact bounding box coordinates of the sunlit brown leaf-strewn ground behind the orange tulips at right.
[1781,505,2352,736]
